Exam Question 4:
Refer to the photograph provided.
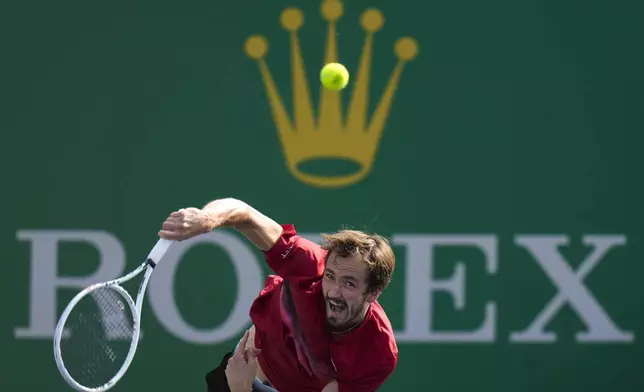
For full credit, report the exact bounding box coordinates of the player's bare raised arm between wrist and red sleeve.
[203,198,282,251]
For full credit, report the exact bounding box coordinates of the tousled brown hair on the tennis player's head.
[322,230,396,292]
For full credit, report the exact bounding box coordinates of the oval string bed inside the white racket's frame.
[60,286,134,388]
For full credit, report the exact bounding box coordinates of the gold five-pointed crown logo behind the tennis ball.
[244,0,418,188]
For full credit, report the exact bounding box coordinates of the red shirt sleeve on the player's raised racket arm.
[264,225,326,279]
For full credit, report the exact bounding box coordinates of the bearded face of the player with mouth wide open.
[322,251,376,331]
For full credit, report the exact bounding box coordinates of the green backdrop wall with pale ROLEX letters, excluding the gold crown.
[0,0,644,392]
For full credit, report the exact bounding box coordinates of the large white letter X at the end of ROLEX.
[510,236,634,342]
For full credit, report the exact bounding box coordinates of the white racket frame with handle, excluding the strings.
[54,238,174,392]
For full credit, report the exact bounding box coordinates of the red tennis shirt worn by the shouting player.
[250,225,398,392]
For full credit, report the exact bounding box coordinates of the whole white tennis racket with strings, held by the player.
[54,239,174,392]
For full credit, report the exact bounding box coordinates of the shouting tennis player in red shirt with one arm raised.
[159,198,398,392]
